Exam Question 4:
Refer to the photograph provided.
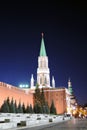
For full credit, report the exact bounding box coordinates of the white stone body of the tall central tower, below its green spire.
[37,56,50,87]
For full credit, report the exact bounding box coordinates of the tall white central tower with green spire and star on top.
[37,33,50,87]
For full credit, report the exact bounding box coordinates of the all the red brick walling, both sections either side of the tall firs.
[0,82,66,114]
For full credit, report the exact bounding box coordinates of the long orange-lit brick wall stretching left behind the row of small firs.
[0,82,33,106]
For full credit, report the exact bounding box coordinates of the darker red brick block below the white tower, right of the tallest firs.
[44,89,66,114]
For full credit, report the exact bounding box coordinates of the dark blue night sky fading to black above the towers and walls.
[0,1,87,104]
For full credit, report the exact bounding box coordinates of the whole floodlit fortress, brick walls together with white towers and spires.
[0,35,77,114]
